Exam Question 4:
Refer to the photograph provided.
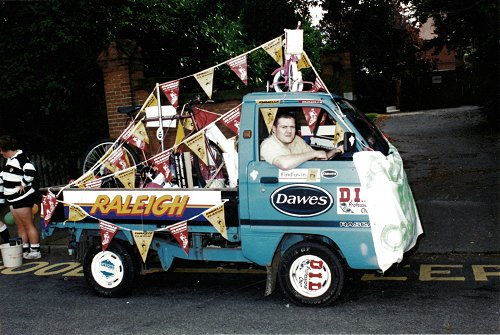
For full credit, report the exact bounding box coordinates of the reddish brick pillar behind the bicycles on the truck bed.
[97,40,148,138]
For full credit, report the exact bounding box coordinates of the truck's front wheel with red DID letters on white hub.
[279,242,345,306]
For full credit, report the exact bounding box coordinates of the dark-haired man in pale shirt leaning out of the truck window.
[260,111,343,170]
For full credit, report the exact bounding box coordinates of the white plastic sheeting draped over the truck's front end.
[353,145,423,271]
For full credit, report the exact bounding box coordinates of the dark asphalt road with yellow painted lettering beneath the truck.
[0,254,500,335]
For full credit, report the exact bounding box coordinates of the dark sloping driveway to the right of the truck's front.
[377,106,500,253]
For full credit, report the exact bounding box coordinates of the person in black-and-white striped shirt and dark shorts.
[0,135,42,259]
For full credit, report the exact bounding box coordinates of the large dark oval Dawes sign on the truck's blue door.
[271,184,333,217]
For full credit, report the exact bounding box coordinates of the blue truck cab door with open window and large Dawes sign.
[247,104,368,233]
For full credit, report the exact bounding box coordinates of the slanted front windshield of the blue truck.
[334,98,389,156]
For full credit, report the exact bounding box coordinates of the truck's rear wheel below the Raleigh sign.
[83,241,140,298]
